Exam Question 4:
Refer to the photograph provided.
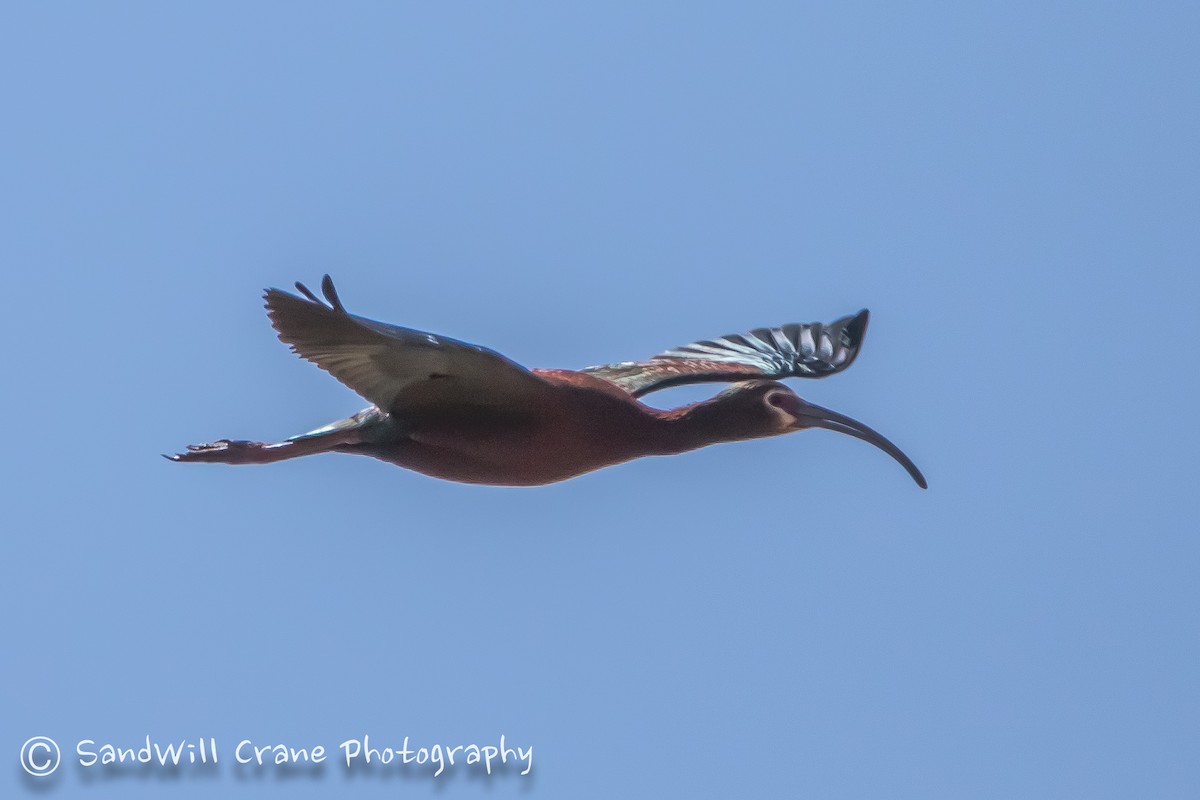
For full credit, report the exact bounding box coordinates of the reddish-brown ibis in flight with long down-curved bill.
[167,275,926,488]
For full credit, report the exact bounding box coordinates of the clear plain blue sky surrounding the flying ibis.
[0,2,1200,799]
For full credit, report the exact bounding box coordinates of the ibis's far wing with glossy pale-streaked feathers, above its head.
[583,308,868,397]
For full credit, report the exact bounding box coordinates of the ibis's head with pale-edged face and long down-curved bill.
[700,380,928,489]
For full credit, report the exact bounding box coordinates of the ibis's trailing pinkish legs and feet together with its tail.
[163,405,395,464]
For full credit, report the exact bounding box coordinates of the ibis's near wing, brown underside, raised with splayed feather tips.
[264,275,548,416]
